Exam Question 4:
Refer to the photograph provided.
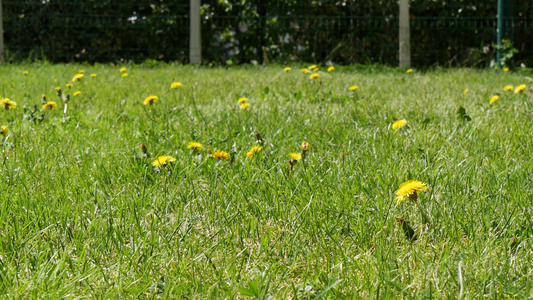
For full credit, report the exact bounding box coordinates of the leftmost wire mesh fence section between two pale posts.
[3,0,189,62]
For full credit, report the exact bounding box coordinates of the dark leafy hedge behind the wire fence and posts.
[3,0,533,67]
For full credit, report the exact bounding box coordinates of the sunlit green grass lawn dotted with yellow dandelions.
[0,64,533,299]
